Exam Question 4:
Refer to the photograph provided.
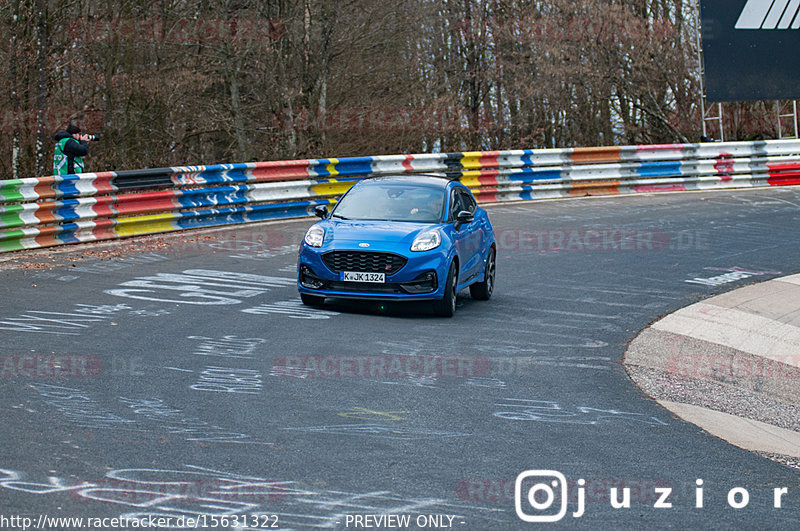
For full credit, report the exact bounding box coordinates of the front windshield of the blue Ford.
[332,183,445,223]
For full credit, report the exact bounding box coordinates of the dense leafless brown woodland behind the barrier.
[0,0,792,178]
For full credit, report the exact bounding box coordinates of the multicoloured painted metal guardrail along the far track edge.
[0,140,800,252]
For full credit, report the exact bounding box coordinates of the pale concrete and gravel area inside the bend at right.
[624,275,800,469]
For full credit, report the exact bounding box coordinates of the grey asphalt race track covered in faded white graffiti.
[0,188,800,530]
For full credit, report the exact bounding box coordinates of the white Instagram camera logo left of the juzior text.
[514,470,580,522]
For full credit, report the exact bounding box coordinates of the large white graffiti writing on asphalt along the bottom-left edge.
[0,464,506,531]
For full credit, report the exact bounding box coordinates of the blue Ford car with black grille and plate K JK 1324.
[297,175,497,317]
